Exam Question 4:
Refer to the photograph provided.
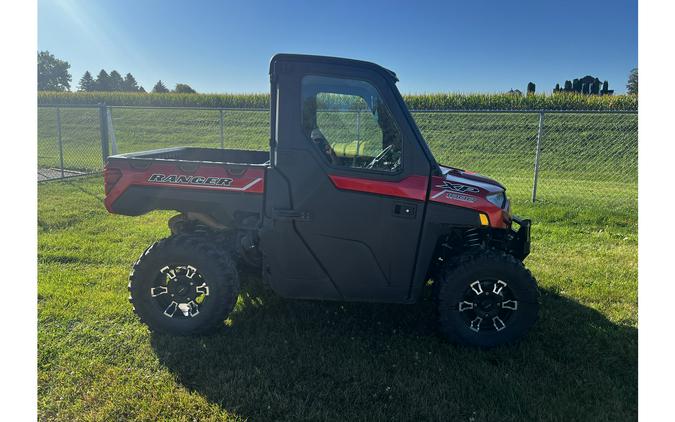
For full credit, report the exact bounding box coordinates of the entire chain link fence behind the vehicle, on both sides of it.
[38,105,638,208]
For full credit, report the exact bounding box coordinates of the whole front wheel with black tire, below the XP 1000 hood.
[436,251,539,347]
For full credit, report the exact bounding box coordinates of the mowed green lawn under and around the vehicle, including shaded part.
[38,176,638,421]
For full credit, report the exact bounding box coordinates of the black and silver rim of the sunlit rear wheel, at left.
[150,264,210,319]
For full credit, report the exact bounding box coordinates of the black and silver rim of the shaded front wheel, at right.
[457,279,519,333]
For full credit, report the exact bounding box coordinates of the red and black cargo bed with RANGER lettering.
[104,147,269,225]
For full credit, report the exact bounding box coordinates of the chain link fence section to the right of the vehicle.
[413,111,638,208]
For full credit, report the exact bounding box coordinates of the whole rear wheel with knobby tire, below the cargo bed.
[129,235,239,335]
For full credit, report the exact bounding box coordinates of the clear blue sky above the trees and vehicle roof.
[38,0,638,93]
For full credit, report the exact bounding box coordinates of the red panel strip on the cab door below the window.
[330,175,429,201]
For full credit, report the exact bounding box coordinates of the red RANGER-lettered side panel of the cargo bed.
[104,161,265,212]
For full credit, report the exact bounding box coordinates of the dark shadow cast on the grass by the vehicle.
[152,276,637,421]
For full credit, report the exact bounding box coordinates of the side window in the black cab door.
[302,76,402,173]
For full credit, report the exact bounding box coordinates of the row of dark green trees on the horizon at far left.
[38,51,197,94]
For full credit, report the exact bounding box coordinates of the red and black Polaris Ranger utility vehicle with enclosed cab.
[105,54,538,346]
